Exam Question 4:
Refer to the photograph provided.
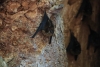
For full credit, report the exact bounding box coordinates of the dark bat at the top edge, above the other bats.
[75,0,92,18]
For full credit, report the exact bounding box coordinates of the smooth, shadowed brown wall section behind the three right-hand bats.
[63,0,100,67]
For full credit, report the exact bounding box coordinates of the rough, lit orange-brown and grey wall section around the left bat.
[0,0,68,67]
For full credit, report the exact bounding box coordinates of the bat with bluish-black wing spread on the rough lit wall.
[32,12,54,44]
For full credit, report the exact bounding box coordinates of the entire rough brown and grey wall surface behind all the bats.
[0,0,100,67]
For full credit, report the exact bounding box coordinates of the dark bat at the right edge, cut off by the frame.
[87,25,100,53]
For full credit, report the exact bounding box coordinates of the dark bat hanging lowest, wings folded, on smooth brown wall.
[66,32,81,61]
